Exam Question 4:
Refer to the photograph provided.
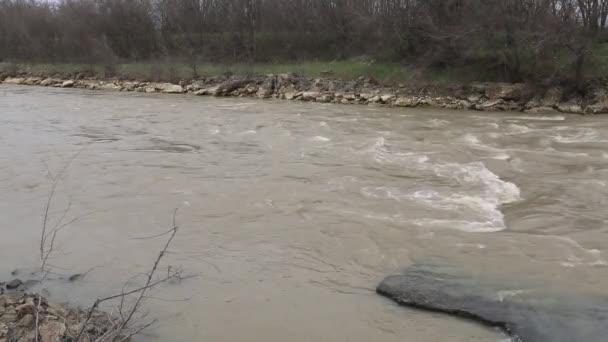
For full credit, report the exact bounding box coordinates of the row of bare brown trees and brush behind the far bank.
[0,0,608,84]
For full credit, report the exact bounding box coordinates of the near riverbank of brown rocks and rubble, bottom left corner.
[0,279,119,342]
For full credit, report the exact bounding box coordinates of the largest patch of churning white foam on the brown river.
[361,134,521,232]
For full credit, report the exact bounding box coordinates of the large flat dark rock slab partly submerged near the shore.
[377,266,608,342]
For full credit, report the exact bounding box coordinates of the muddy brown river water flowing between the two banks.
[0,86,608,342]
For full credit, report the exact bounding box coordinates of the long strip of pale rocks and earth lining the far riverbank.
[0,73,608,114]
